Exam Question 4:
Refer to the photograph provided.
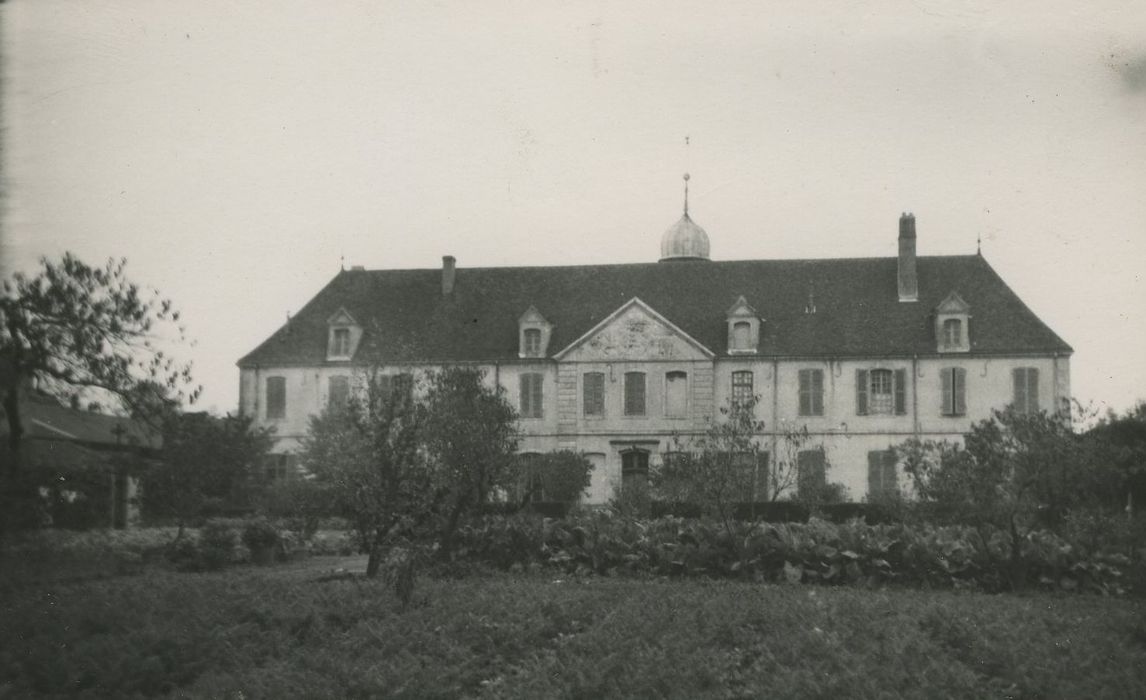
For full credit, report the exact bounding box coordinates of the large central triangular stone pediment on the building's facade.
[555,297,714,362]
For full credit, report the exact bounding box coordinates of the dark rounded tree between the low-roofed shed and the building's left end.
[142,412,273,541]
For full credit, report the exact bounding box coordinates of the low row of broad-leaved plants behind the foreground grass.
[455,512,1131,595]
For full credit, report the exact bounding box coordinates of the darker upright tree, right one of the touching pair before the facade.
[424,367,518,556]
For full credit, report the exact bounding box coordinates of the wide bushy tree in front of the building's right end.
[897,408,1108,585]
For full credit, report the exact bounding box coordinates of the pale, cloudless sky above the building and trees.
[0,0,1146,411]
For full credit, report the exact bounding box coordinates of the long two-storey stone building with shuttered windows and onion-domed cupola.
[238,186,1072,503]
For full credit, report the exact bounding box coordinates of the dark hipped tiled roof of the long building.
[238,255,1072,367]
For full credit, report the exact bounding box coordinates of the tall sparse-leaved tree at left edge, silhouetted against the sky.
[0,253,199,532]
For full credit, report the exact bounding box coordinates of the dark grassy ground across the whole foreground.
[0,559,1146,699]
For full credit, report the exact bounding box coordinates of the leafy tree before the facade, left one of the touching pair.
[300,372,426,577]
